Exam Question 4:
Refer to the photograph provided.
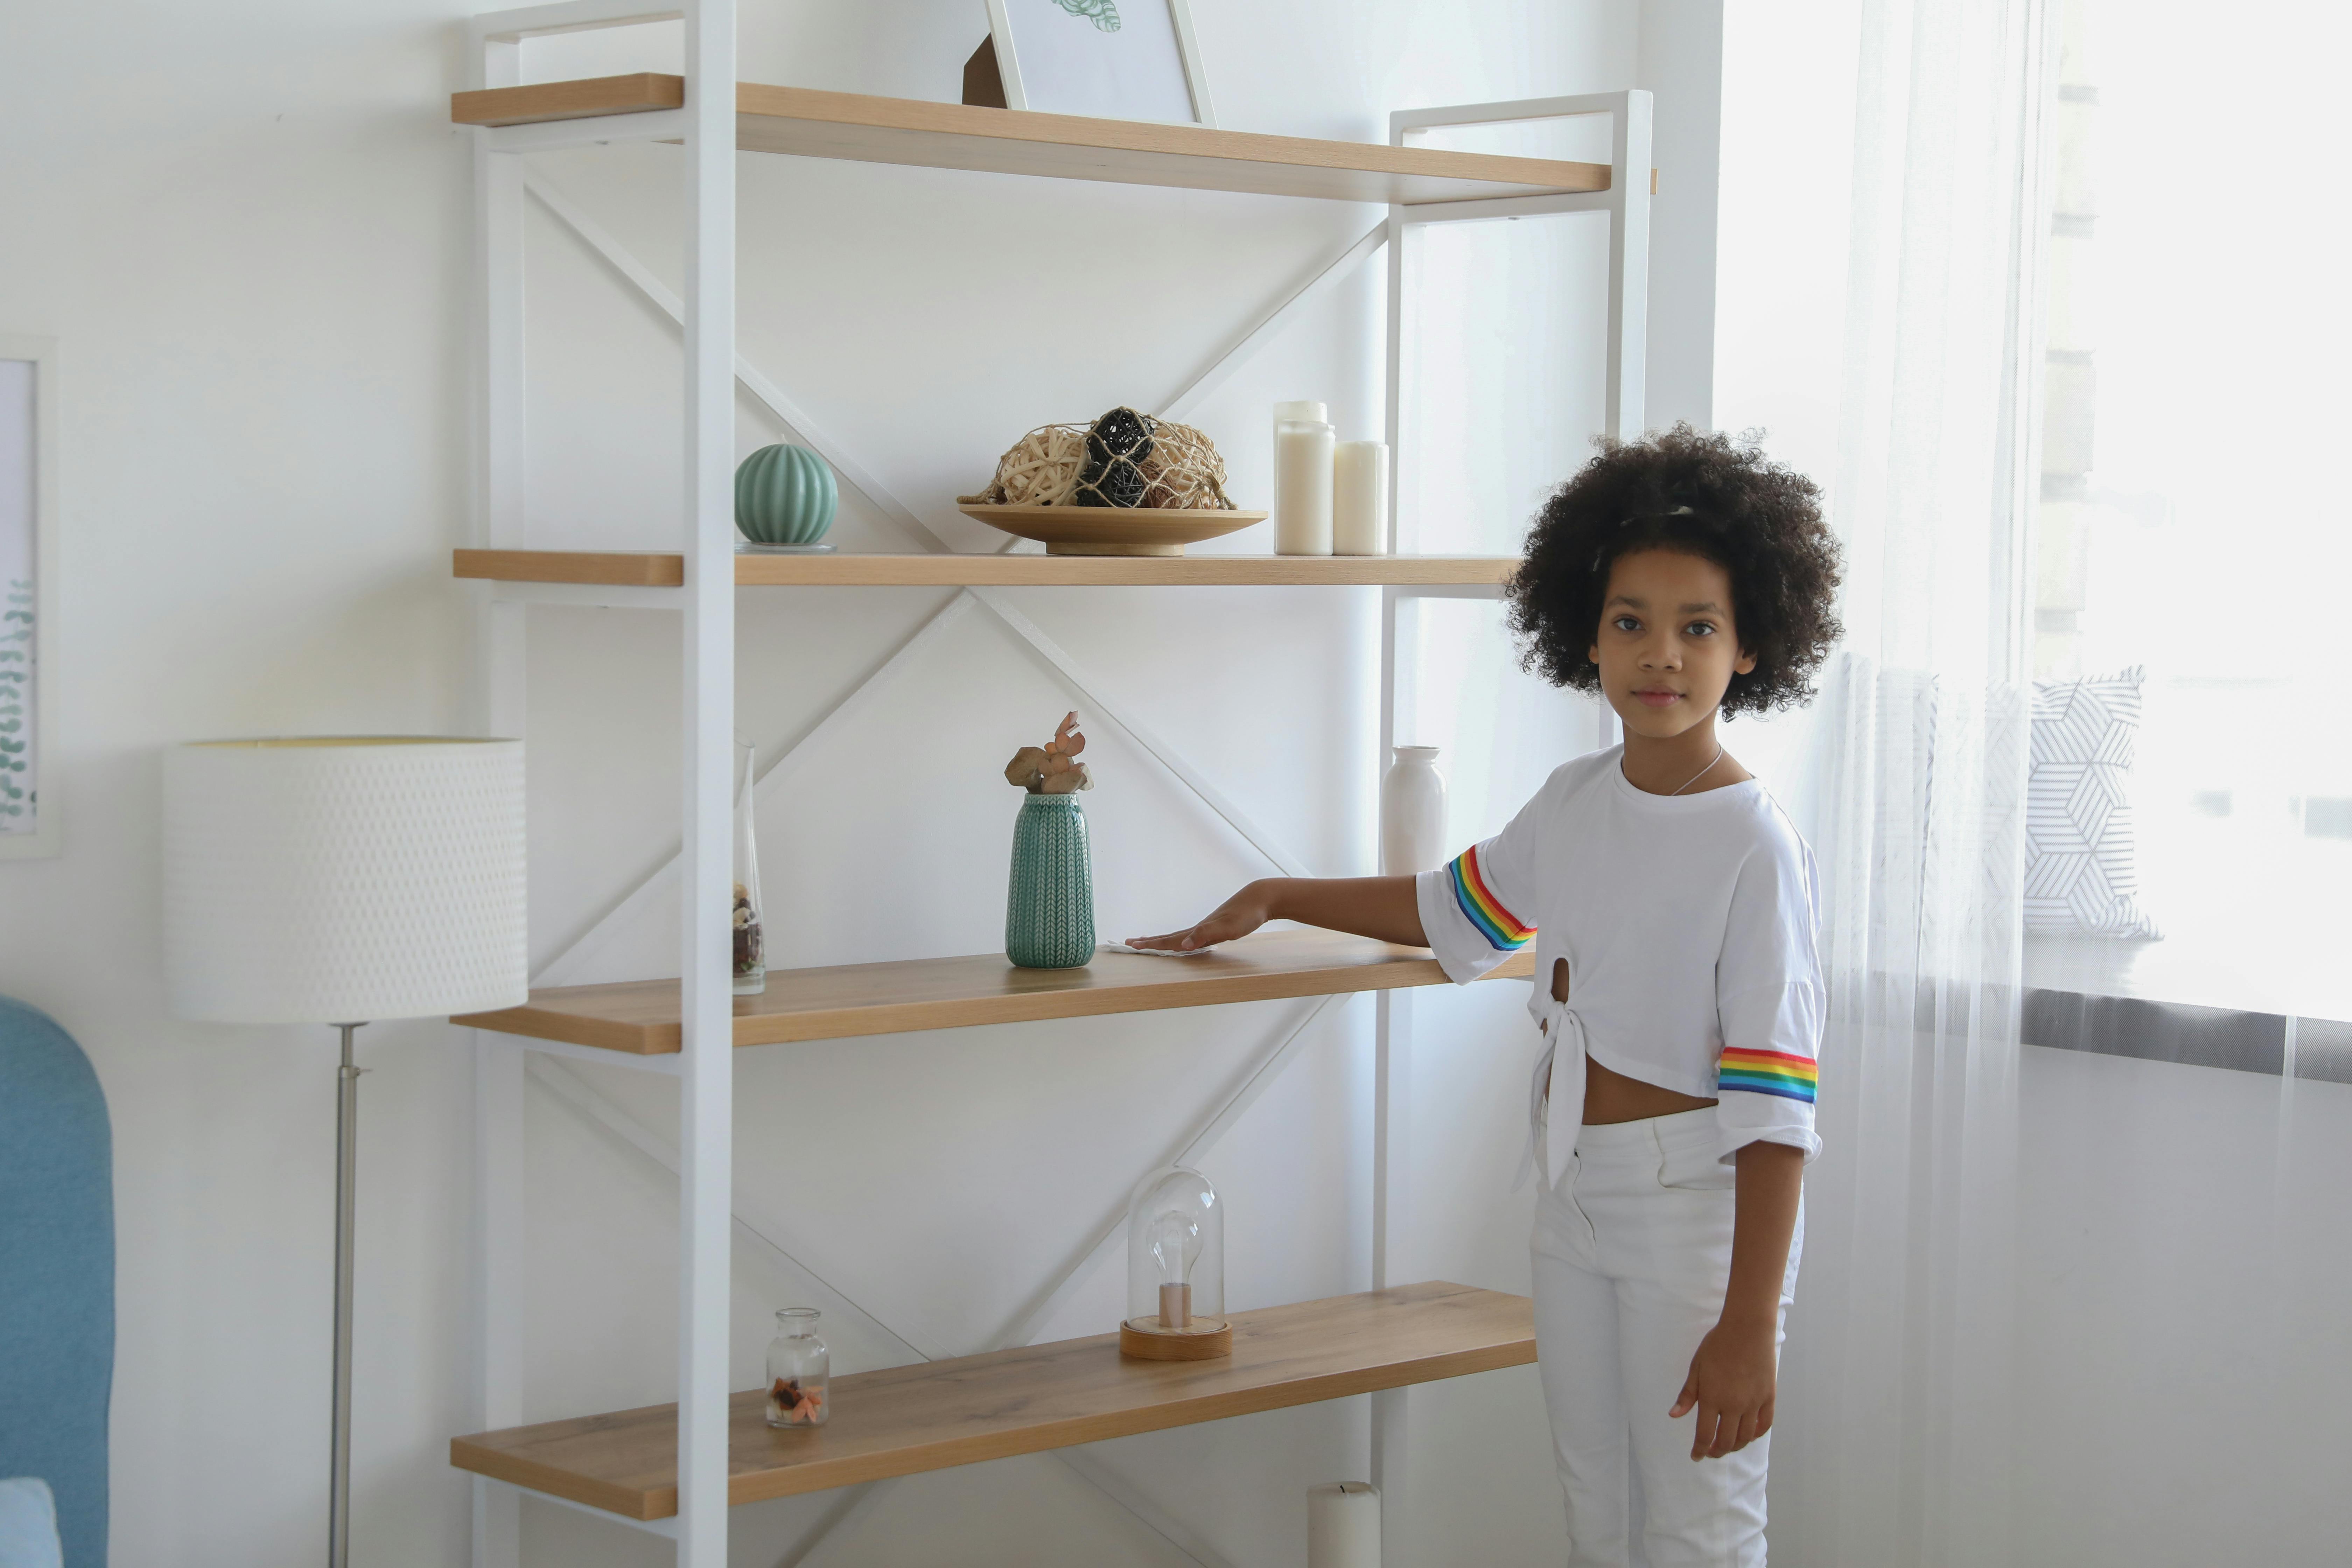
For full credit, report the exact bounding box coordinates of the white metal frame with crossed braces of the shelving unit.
[449,0,1651,1568]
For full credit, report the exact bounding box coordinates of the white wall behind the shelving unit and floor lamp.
[0,0,1712,1568]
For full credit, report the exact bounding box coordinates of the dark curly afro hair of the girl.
[1503,423,1844,719]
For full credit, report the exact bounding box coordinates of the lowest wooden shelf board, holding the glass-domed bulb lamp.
[449,1281,1536,1519]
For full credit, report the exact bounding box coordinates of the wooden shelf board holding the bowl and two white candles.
[454,550,1519,588]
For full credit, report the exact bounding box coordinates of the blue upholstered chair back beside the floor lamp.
[0,997,115,1568]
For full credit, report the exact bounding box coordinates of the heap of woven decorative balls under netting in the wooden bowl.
[957,407,1235,512]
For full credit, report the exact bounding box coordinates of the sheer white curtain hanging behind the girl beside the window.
[1773,0,2042,1568]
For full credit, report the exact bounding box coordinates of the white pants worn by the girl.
[1533,1110,1804,1568]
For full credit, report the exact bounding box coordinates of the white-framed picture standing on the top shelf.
[988,0,1216,127]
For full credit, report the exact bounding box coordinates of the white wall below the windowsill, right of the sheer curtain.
[2016,1049,2352,1568]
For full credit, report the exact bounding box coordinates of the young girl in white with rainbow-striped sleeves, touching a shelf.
[1134,426,1839,1568]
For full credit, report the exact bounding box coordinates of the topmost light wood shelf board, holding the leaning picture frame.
[449,73,1609,204]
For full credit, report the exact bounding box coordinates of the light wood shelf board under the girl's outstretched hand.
[449,931,1536,1056]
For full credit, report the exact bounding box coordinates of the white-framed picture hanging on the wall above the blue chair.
[0,334,63,860]
